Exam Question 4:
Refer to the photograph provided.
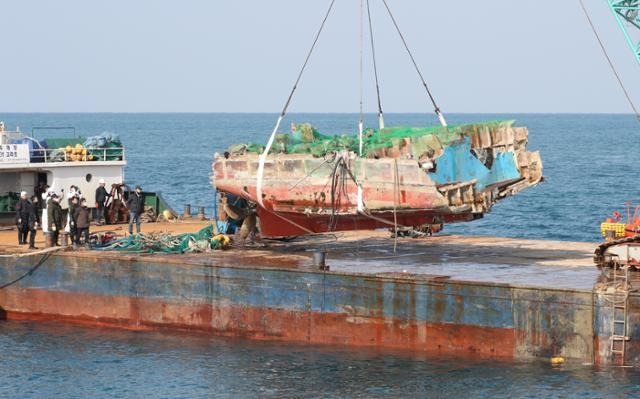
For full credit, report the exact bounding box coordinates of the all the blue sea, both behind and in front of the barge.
[0,113,640,398]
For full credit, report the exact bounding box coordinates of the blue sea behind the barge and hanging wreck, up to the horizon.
[0,113,640,241]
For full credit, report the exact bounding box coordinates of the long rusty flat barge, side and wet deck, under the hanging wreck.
[0,224,640,366]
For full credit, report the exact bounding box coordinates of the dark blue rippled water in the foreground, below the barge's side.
[0,322,640,398]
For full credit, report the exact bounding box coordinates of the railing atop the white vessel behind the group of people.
[30,147,125,163]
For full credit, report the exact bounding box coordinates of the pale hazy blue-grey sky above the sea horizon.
[0,0,640,113]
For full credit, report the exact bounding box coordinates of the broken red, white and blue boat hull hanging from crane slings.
[212,123,542,236]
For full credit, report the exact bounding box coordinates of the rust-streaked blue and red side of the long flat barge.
[0,239,640,365]
